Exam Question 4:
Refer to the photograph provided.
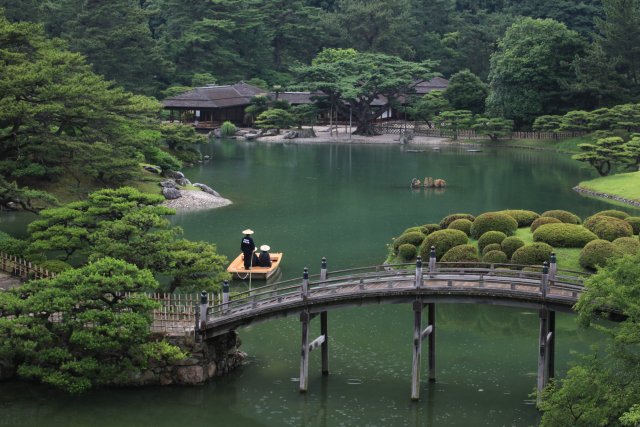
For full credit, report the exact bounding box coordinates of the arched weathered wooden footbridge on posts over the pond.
[197,255,588,400]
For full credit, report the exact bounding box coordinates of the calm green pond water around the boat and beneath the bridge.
[0,141,632,427]
